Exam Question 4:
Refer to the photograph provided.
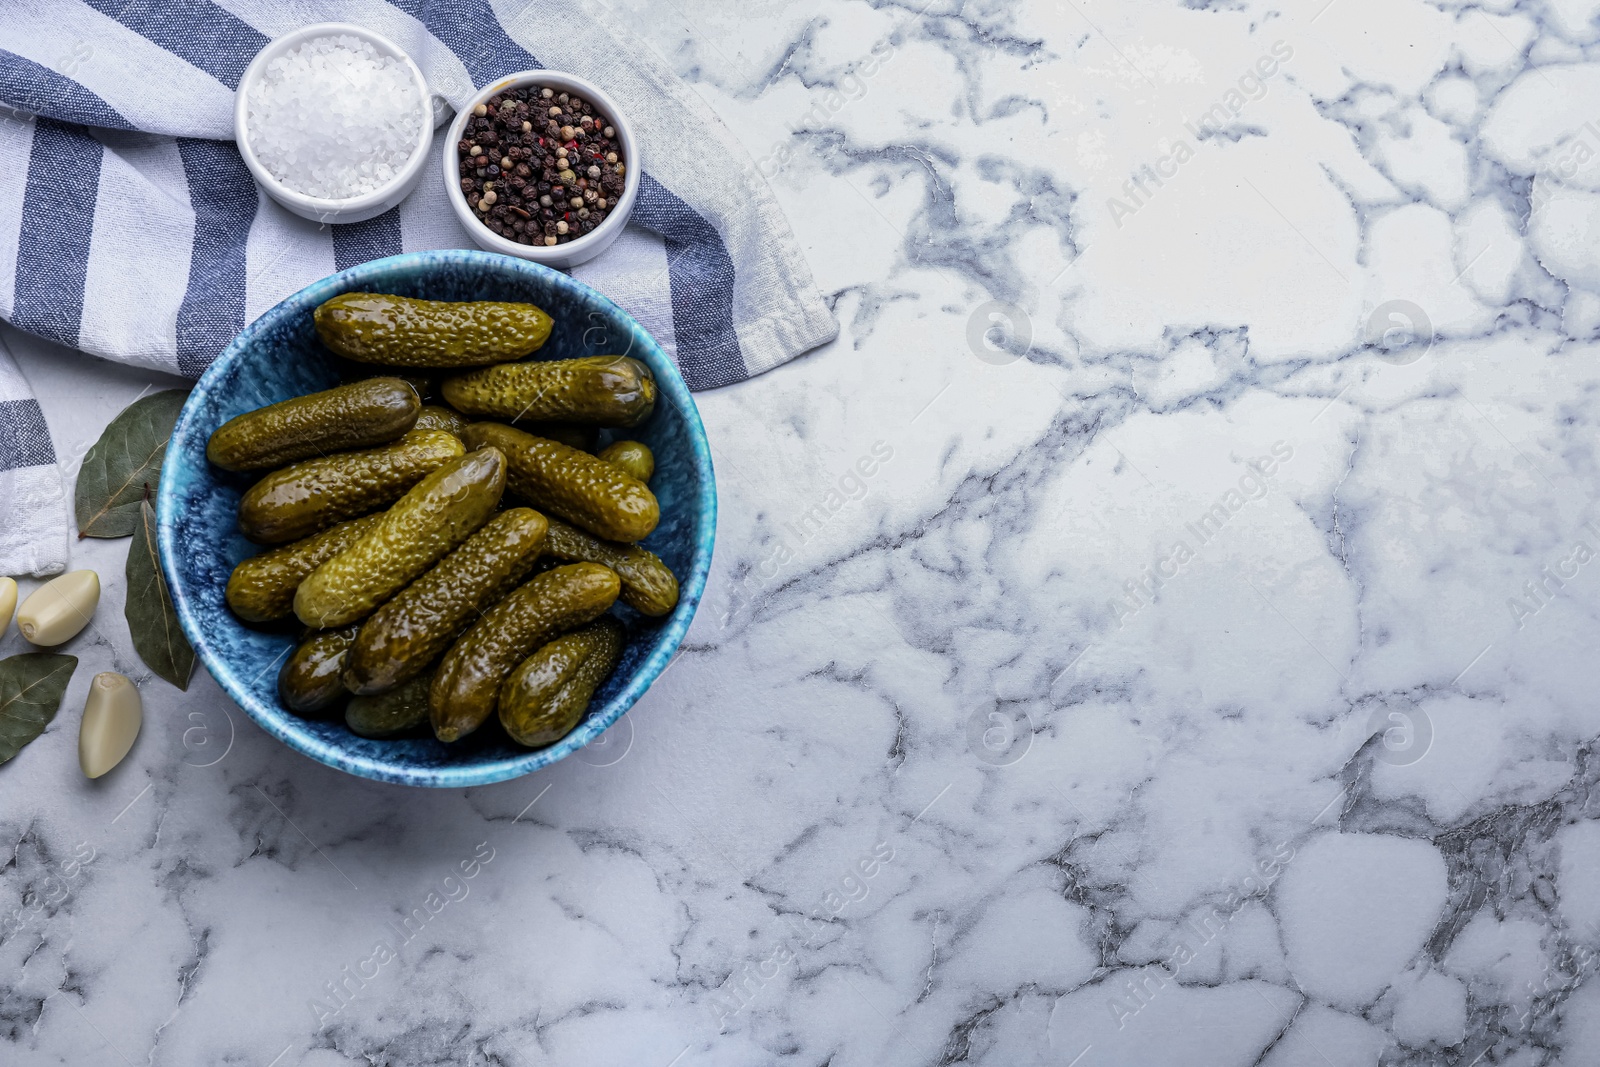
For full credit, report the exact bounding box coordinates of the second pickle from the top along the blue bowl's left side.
[238,430,466,544]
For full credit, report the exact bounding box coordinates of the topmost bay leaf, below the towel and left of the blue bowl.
[74,389,189,537]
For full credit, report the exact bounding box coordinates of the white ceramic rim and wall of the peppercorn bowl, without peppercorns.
[443,70,645,269]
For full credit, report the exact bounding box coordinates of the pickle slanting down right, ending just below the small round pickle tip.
[462,422,661,541]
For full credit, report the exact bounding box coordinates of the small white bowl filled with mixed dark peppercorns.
[445,70,643,267]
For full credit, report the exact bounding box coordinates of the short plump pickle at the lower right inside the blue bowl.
[499,616,624,749]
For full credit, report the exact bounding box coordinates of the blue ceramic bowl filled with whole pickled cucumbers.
[157,250,717,787]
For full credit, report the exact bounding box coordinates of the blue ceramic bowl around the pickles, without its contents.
[157,250,717,787]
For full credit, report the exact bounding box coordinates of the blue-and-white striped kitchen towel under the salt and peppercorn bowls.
[0,0,838,573]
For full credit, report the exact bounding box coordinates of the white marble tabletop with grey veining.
[0,0,1600,1067]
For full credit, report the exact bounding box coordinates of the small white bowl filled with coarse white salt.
[234,22,434,222]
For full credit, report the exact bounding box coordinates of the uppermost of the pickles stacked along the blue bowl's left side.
[205,378,422,470]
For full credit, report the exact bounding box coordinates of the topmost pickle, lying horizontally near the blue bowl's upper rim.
[314,293,550,366]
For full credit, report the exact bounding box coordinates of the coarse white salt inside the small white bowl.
[246,34,424,200]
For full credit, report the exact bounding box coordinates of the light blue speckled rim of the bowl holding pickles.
[157,248,717,789]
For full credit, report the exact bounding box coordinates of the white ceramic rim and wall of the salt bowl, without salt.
[234,22,434,222]
